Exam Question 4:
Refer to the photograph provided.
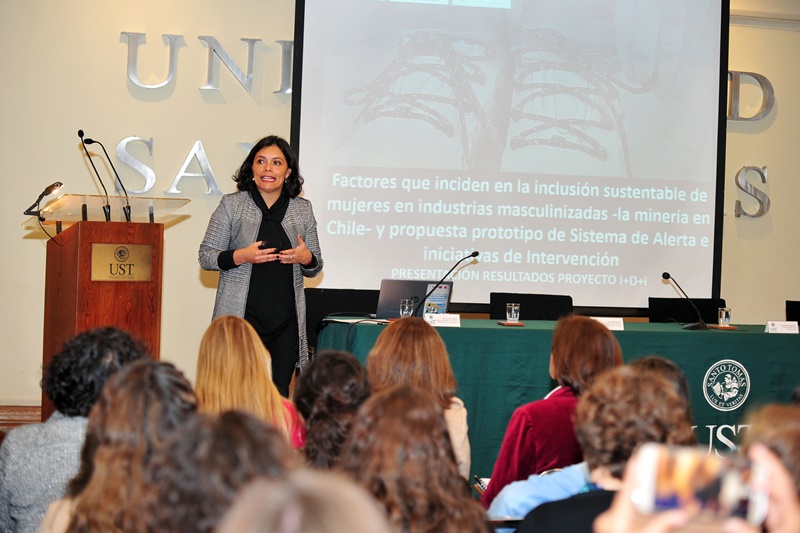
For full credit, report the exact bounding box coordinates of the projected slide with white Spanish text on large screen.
[294,0,722,307]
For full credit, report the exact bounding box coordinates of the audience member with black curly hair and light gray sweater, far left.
[0,327,146,533]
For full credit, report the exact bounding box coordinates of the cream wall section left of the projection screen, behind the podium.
[0,0,294,405]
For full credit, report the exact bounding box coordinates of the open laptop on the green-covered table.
[375,279,453,319]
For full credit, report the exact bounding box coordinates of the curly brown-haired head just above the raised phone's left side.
[575,365,695,478]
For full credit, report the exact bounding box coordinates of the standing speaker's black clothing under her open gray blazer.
[244,189,297,342]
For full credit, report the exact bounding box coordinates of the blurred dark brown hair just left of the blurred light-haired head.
[134,411,299,533]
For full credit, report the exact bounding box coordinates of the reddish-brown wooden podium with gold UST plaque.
[37,195,188,420]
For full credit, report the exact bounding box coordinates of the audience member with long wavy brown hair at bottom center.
[341,384,490,533]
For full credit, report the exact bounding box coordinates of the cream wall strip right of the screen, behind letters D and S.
[721,0,800,324]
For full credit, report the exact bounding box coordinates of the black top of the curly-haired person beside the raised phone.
[517,490,616,533]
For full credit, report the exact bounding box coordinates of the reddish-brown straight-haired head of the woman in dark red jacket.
[550,315,622,396]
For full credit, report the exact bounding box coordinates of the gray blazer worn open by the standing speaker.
[199,191,323,367]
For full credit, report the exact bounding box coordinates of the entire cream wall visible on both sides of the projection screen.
[0,0,800,405]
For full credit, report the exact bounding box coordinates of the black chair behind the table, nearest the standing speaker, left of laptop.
[305,287,380,354]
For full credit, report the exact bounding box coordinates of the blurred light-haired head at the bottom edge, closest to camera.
[218,470,390,533]
